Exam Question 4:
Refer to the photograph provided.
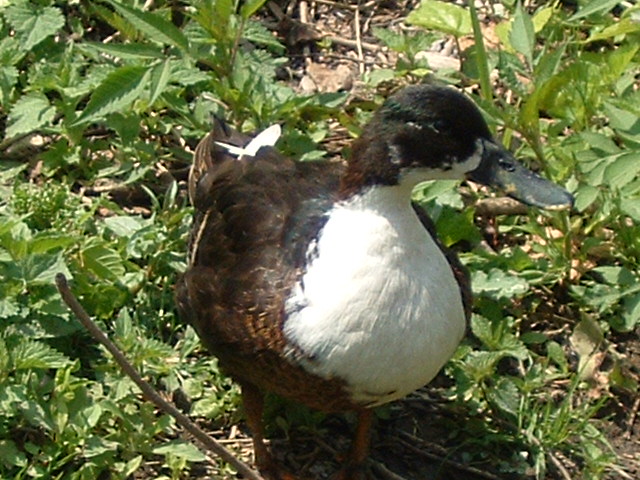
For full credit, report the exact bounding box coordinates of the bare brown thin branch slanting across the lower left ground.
[56,273,264,480]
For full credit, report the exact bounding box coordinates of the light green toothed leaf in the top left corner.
[4,0,64,52]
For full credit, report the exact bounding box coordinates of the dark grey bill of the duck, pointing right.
[467,141,573,210]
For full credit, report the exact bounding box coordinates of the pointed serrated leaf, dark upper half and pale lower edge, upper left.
[73,65,149,126]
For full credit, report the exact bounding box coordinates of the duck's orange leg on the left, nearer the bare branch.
[240,382,295,480]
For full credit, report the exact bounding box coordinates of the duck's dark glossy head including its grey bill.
[342,85,573,209]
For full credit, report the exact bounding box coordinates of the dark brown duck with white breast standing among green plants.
[176,84,573,480]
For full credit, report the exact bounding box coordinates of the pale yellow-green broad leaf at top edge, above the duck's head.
[407,0,473,37]
